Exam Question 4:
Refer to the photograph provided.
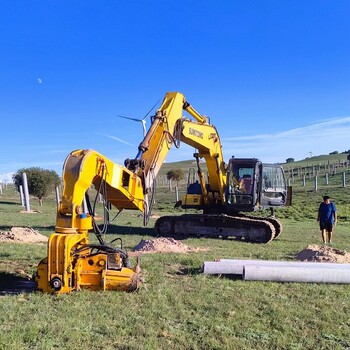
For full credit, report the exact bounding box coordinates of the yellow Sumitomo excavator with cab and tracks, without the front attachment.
[125,92,287,243]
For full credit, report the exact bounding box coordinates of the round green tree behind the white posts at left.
[13,167,61,206]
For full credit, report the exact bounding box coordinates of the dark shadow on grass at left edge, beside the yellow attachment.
[0,272,36,295]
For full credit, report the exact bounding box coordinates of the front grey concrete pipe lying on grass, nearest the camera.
[243,263,350,283]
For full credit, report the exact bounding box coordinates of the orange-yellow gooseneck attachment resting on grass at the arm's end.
[36,150,145,293]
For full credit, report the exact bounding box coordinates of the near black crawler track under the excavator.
[155,214,276,243]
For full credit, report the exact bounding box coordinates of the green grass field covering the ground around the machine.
[0,168,350,349]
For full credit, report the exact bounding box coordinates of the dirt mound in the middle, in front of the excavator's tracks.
[134,237,206,253]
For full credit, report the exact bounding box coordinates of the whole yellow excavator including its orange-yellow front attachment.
[35,92,287,293]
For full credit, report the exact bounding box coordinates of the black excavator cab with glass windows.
[225,157,287,213]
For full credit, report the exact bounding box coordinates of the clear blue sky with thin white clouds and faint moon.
[0,0,350,183]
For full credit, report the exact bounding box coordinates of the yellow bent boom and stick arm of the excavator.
[125,92,226,211]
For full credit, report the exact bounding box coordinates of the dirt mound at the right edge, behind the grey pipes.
[297,245,350,263]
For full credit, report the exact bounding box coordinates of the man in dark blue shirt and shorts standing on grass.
[317,196,337,244]
